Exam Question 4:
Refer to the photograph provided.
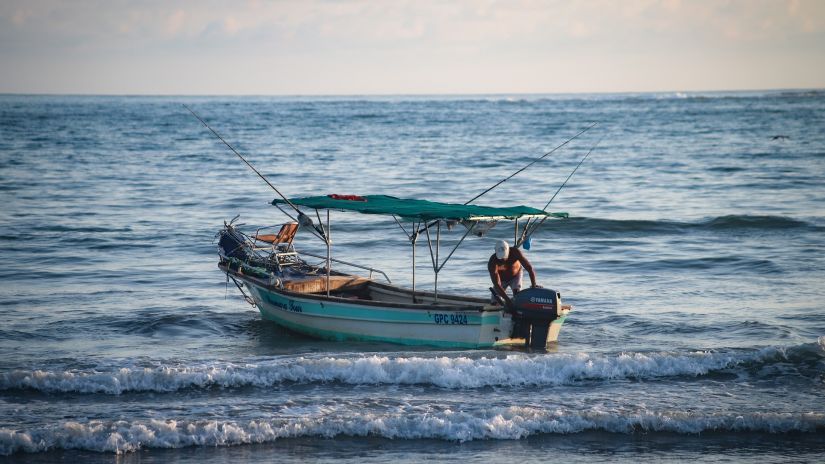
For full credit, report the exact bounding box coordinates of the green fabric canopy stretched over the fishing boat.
[272,195,568,221]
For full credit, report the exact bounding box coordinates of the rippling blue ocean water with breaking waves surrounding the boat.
[0,91,825,463]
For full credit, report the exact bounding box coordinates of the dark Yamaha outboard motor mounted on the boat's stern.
[512,288,561,349]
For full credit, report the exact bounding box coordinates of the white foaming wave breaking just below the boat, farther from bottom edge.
[0,337,825,395]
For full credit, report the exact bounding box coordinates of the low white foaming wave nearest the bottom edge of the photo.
[0,407,825,455]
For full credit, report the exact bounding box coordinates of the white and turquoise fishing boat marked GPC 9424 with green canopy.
[218,195,571,348]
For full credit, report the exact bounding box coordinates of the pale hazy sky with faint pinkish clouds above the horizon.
[0,0,825,95]
